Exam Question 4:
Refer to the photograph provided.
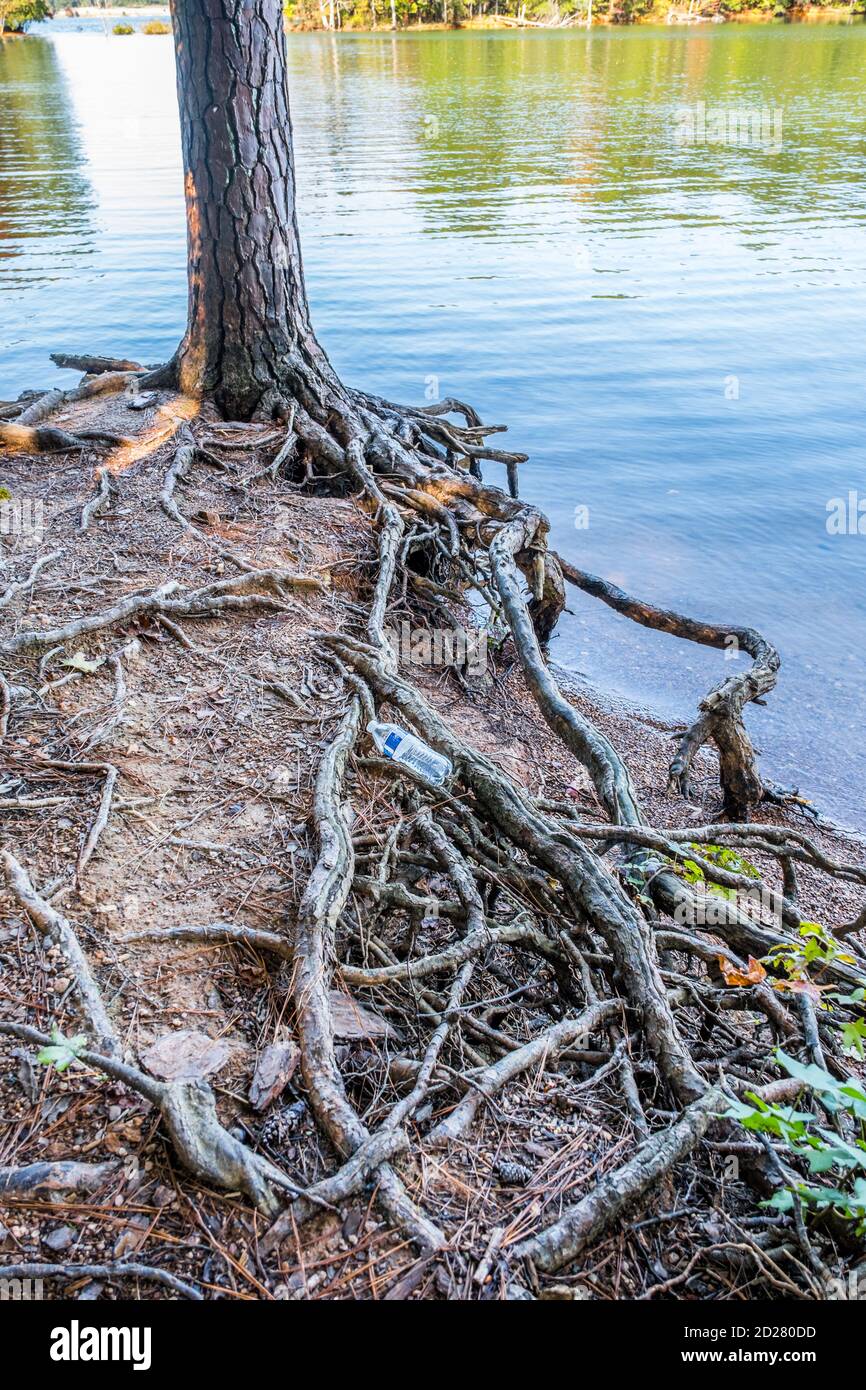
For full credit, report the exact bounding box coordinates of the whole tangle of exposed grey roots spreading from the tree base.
[0,354,866,1295]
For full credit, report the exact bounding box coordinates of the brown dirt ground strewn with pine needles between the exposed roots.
[0,396,863,1300]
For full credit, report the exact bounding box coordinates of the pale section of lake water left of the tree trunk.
[0,33,185,395]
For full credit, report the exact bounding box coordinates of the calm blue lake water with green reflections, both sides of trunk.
[0,21,866,827]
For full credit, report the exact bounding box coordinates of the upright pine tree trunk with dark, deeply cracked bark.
[171,0,334,420]
